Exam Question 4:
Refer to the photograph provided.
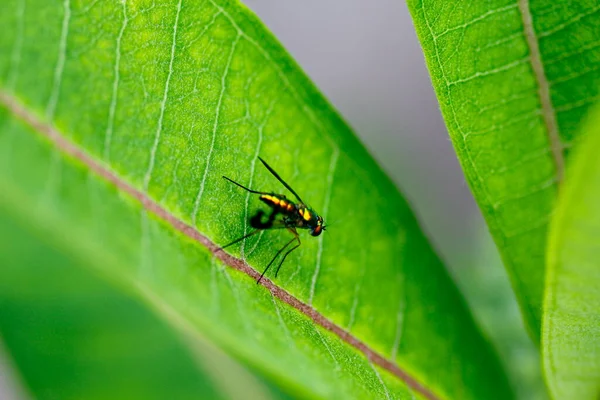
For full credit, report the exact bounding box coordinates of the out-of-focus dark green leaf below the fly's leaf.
[0,209,285,399]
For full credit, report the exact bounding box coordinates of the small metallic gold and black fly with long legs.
[221,157,325,283]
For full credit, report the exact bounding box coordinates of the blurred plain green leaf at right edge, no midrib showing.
[542,102,600,399]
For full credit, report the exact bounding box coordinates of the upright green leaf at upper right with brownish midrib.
[409,0,600,339]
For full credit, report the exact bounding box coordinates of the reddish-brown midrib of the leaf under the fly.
[0,90,440,400]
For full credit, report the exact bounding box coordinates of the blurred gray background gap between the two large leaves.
[243,0,546,399]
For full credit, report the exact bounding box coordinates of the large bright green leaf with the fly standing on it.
[0,0,511,399]
